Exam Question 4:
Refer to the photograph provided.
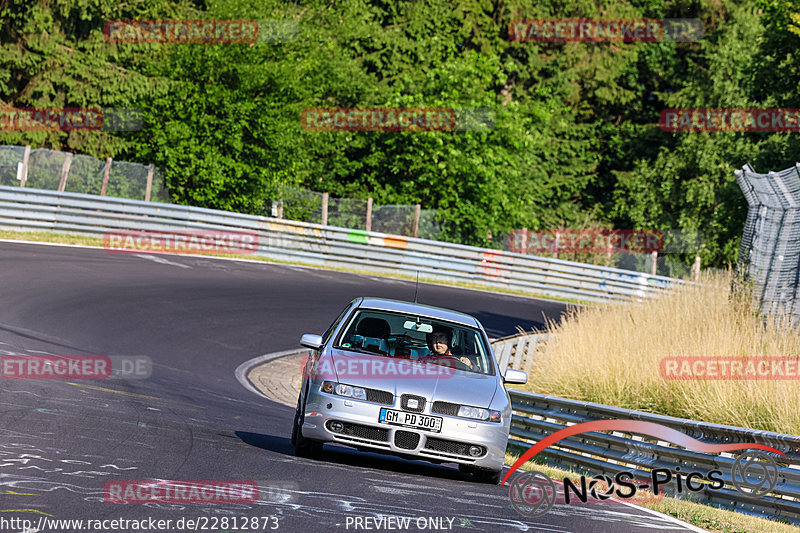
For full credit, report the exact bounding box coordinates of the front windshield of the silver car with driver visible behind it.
[335,309,494,375]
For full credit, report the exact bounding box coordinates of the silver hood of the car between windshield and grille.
[330,349,499,408]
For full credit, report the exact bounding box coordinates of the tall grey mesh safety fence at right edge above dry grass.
[735,163,800,320]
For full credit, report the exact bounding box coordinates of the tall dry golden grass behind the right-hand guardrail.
[527,274,800,435]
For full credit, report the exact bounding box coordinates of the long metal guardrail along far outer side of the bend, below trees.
[0,186,684,302]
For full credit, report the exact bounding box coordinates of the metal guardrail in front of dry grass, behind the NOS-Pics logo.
[509,390,800,524]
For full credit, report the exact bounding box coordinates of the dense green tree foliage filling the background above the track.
[0,0,800,265]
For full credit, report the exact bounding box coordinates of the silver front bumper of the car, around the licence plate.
[302,391,509,471]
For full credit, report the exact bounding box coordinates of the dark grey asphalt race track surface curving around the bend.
[0,242,700,533]
